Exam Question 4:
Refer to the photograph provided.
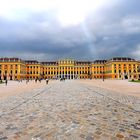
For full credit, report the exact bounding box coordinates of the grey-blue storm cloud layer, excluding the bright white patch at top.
[0,0,140,60]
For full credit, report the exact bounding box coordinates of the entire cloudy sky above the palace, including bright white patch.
[0,0,140,61]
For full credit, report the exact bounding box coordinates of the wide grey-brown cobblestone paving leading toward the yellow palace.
[0,80,140,140]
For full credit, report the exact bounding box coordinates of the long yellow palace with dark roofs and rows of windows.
[0,57,140,80]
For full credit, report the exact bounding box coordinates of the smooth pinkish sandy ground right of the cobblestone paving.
[80,79,140,97]
